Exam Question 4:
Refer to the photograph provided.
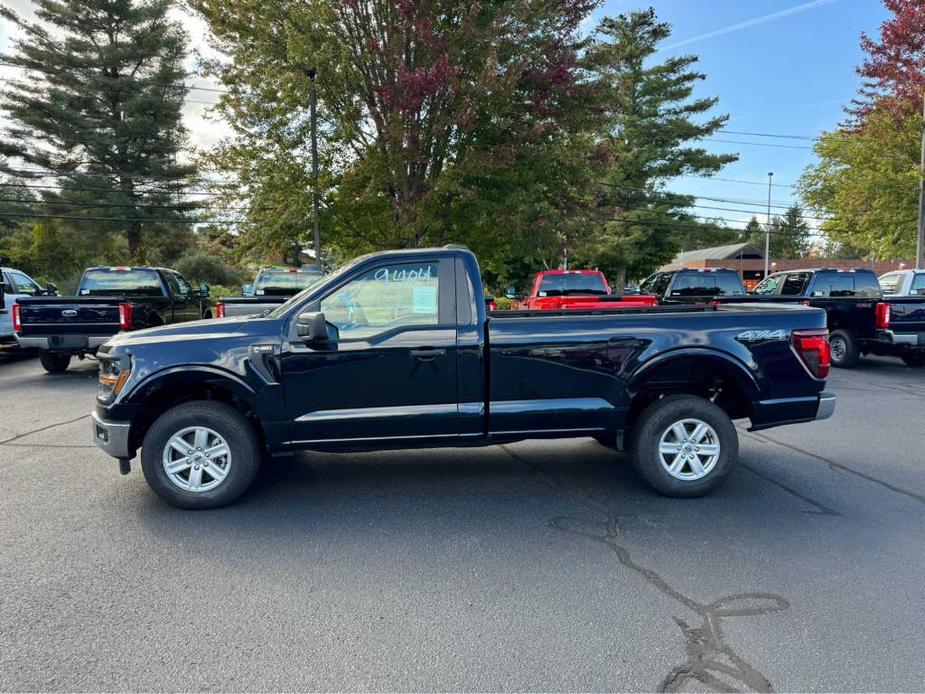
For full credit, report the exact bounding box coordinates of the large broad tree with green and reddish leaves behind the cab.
[193,0,597,274]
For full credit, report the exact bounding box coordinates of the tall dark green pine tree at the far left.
[0,0,192,261]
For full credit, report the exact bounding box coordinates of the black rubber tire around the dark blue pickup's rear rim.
[629,395,739,498]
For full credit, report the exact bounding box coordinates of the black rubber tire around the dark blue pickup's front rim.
[141,400,261,509]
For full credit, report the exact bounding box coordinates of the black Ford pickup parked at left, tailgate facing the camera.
[13,267,212,373]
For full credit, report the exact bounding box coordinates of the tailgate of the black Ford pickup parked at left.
[17,297,119,336]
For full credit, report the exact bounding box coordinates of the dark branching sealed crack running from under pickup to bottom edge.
[501,445,790,692]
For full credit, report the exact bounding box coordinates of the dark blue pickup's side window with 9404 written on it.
[321,262,440,340]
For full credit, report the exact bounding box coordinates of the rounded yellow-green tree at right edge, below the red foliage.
[799,103,922,259]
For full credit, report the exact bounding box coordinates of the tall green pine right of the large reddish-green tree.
[585,9,737,286]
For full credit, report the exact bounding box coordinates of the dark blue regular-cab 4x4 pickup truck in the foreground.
[91,247,835,508]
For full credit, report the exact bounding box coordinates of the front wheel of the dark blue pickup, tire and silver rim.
[141,400,260,509]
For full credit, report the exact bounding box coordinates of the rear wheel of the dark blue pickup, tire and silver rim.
[629,395,739,497]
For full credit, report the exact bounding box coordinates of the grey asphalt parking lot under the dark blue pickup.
[0,355,925,691]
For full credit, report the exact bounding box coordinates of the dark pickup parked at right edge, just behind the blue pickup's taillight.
[720,268,925,368]
